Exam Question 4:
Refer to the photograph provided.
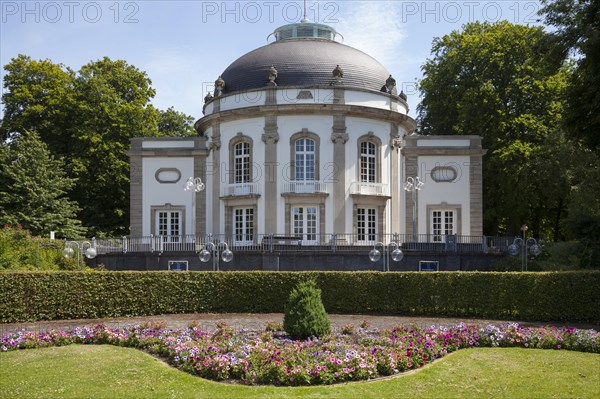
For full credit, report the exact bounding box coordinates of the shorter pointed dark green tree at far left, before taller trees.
[0,130,85,237]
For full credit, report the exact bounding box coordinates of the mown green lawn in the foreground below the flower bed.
[0,345,600,399]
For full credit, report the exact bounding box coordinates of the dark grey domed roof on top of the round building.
[221,22,390,94]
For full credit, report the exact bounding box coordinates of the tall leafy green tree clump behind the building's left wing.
[0,55,193,235]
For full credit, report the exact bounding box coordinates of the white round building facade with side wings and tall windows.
[130,21,485,245]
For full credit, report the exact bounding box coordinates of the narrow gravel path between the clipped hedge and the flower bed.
[0,313,599,333]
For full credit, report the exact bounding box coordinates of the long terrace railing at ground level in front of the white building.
[95,234,514,254]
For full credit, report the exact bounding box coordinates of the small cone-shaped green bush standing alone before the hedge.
[283,280,331,339]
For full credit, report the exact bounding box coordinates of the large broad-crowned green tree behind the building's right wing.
[418,21,570,236]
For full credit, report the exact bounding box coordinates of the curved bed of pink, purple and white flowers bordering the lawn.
[0,323,600,385]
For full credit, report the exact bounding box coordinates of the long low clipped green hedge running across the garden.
[0,271,600,324]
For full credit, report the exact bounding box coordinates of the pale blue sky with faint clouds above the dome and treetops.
[0,0,541,119]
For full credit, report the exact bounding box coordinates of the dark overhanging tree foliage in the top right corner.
[540,0,600,148]
